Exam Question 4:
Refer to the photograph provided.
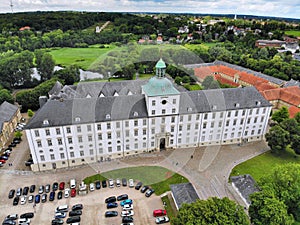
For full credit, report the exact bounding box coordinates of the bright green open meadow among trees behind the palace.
[49,45,115,70]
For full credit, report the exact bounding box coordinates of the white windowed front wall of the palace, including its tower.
[26,59,272,171]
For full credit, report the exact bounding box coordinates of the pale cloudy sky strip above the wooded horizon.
[0,0,300,19]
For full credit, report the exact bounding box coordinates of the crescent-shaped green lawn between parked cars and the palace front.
[84,166,189,195]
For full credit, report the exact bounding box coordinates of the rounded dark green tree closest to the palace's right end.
[266,125,289,152]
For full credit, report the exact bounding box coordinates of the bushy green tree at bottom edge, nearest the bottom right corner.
[249,190,294,225]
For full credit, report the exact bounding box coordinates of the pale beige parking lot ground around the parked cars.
[0,178,169,225]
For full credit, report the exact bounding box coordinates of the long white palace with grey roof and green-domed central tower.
[26,59,272,171]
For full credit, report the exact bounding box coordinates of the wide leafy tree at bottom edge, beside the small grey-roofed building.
[172,197,250,225]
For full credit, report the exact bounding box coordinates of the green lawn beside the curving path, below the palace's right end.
[231,151,300,181]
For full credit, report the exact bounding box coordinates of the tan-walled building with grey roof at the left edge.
[0,101,22,149]
